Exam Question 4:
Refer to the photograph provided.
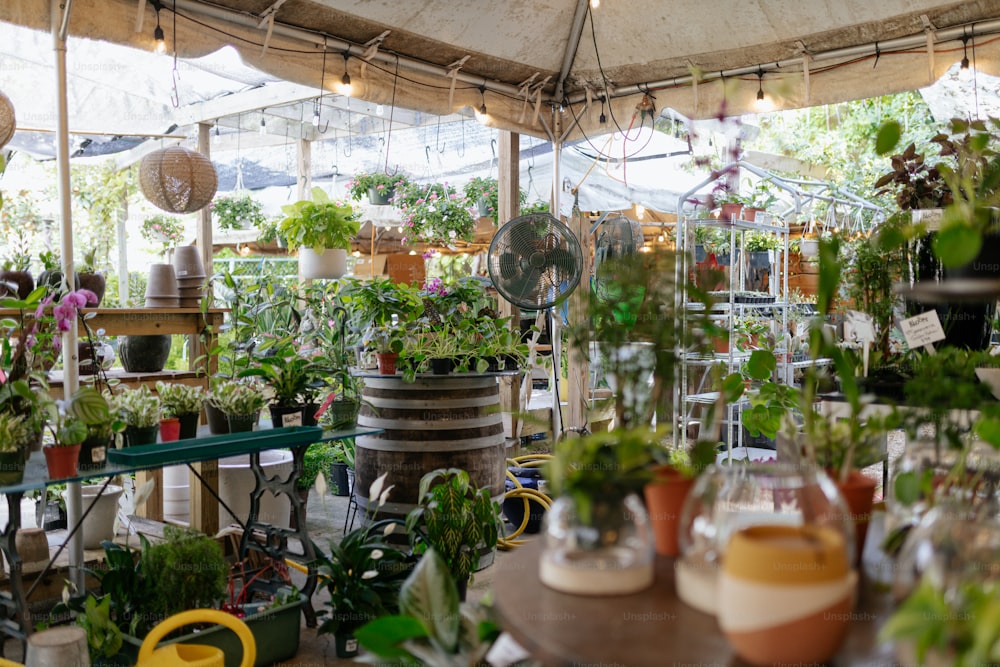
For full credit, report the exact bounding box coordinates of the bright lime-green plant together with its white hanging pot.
[278,187,361,278]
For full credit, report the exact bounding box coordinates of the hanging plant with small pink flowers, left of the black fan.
[395,183,476,246]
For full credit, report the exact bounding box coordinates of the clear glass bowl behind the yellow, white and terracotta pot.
[676,462,854,614]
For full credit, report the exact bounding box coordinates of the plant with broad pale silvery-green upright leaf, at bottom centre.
[355,549,500,667]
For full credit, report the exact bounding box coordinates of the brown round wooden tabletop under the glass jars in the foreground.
[493,539,897,667]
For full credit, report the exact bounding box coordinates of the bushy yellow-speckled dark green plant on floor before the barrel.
[404,468,500,600]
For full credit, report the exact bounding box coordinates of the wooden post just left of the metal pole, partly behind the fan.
[497,130,531,448]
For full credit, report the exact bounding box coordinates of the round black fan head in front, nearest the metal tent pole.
[487,213,583,310]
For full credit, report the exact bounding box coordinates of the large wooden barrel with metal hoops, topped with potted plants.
[354,375,506,518]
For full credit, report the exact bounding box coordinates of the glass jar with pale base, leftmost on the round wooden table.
[539,494,654,595]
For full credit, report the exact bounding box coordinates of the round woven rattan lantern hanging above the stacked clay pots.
[139,146,218,213]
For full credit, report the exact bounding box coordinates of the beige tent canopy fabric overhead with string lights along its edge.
[0,0,1000,138]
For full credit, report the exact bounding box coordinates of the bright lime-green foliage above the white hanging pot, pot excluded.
[278,187,361,253]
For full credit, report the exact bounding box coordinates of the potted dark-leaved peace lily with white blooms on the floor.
[317,475,411,658]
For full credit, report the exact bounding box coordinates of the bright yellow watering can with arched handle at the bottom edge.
[136,609,257,667]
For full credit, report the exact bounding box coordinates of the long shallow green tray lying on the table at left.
[108,426,323,468]
